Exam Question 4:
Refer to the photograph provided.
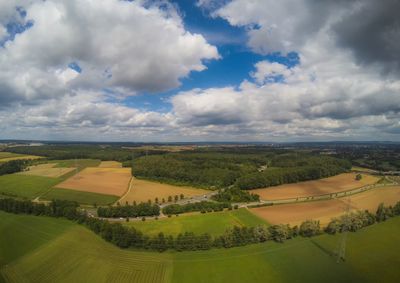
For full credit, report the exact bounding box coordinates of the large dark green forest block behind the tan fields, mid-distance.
[132,152,351,190]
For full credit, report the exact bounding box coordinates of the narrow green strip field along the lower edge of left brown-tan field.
[41,188,119,205]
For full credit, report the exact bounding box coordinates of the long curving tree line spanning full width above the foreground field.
[0,198,400,252]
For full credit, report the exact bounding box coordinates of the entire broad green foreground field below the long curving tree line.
[0,212,400,283]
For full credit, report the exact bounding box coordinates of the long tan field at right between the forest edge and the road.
[251,173,379,200]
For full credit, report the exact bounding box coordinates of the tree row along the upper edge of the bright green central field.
[162,201,232,215]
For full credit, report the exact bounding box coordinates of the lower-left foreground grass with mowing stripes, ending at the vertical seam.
[0,213,171,283]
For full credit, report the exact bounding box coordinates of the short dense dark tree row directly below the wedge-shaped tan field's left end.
[97,202,160,218]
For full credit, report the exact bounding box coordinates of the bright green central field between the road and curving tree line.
[124,208,266,235]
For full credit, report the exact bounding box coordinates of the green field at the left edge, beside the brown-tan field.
[0,174,60,199]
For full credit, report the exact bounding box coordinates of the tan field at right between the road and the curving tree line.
[250,186,400,225]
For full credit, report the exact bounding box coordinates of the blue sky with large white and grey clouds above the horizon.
[0,0,400,142]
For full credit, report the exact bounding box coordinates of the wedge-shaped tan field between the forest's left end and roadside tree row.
[120,178,210,203]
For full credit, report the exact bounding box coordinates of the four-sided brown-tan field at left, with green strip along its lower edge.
[57,167,131,196]
